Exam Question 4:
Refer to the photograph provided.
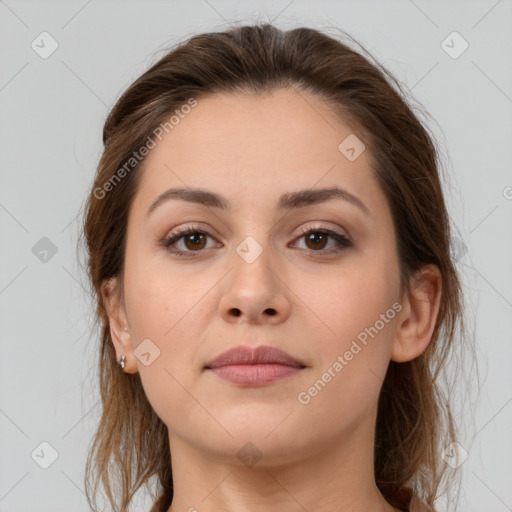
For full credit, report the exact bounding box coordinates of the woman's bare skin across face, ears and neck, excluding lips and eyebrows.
[103,89,441,512]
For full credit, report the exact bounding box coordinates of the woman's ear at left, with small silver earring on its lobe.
[101,276,137,373]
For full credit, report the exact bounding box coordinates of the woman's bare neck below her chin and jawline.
[168,410,398,512]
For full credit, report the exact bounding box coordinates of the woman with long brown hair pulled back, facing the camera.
[84,25,470,512]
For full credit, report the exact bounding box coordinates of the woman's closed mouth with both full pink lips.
[204,345,306,387]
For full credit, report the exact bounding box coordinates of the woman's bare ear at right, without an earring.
[391,264,442,363]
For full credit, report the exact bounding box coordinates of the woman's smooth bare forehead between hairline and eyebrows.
[134,89,383,216]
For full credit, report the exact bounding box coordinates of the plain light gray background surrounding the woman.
[0,0,512,512]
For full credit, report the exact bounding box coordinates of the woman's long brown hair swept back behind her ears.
[79,24,476,512]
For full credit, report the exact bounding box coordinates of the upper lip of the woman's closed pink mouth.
[205,345,305,370]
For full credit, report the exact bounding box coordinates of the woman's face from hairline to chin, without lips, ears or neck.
[110,90,400,464]
